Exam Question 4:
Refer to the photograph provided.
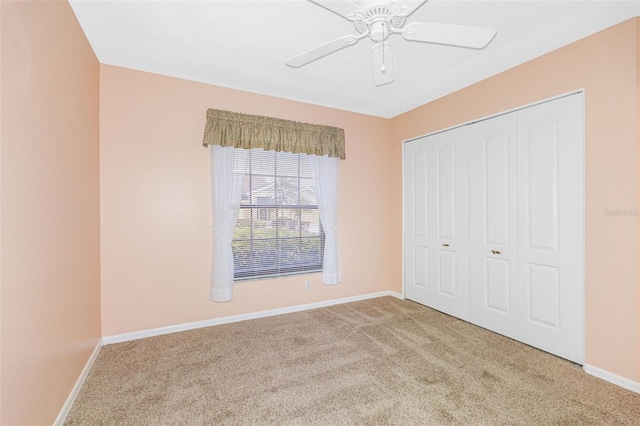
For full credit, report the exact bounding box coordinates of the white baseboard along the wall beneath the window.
[102,290,404,345]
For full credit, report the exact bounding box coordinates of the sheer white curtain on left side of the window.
[209,145,249,302]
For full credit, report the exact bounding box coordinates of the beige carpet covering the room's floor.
[65,297,640,425]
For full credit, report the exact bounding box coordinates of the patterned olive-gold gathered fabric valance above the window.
[202,109,345,159]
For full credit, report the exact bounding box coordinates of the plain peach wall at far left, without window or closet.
[0,1,101,425]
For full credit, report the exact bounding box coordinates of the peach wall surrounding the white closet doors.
[388,19,640,382]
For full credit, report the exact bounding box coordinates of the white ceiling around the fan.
[70,0,640,118]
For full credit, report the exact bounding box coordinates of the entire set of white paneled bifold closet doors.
[403,93,584,363]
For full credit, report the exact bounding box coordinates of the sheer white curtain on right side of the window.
[308,155,342,285]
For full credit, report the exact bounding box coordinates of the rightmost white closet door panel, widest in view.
[517,94,584,364]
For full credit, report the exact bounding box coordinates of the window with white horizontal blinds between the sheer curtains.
[231,149,325,281]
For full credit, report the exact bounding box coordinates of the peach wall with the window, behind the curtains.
[100,65,391,336]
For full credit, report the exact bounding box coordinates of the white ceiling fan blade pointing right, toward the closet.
[402,22,496,49]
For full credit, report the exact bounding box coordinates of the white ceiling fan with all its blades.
[286,0,496,86]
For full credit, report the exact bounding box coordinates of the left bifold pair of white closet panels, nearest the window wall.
[404,128,469,320]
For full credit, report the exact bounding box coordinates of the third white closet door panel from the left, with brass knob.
[469,113,518,339]
